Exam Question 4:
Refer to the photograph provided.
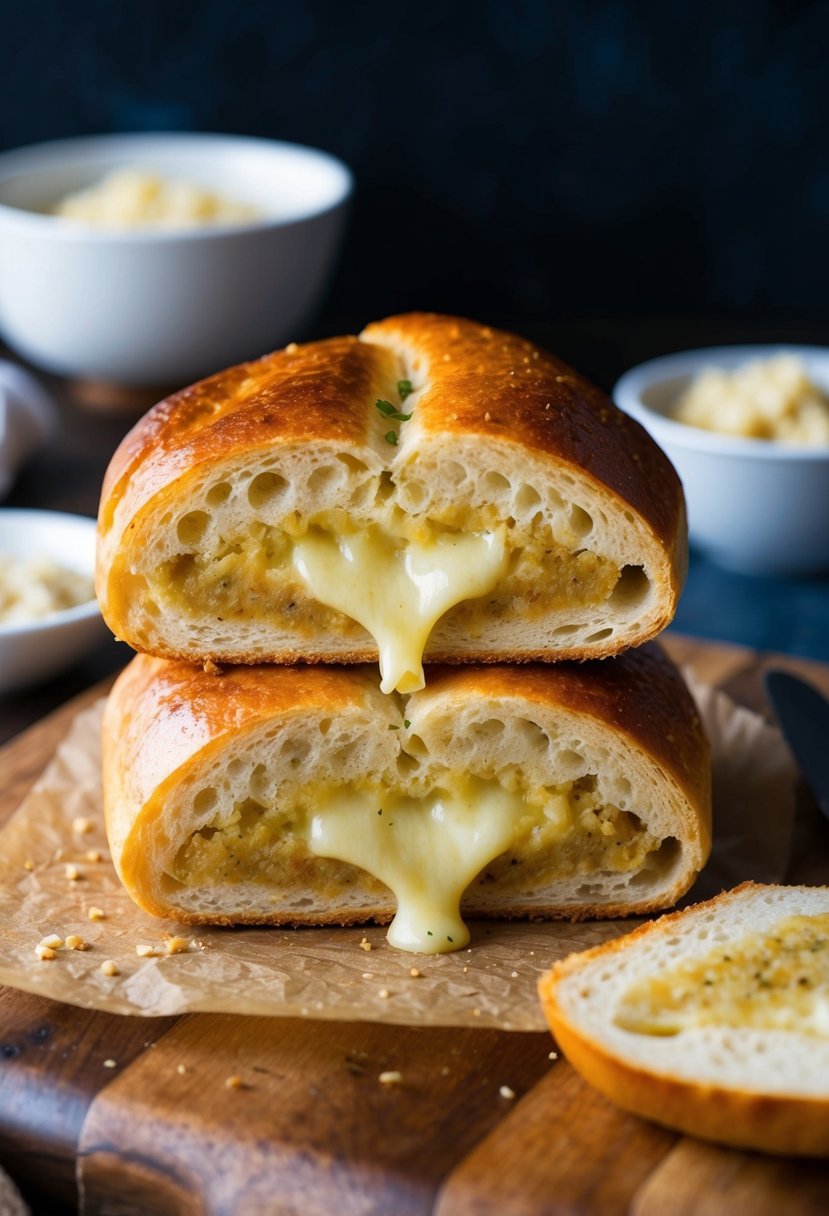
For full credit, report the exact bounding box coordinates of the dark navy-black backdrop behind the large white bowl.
[0,0,829,322]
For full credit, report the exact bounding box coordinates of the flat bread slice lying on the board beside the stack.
[540,883,829,1156]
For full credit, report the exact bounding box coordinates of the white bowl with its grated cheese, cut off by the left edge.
[0,508,107,696]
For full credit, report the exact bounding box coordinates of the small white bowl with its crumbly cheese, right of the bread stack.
[613,345,829,575]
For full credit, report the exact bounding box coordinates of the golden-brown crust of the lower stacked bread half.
[103,646,710,924]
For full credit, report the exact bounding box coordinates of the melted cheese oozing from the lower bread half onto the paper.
[309,778,528,955]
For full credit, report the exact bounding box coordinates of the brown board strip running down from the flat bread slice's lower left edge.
[435,1060,677,1216]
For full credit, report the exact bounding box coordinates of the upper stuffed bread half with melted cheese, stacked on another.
[97,314,687,692]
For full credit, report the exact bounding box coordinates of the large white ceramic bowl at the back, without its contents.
[0,134,351,385]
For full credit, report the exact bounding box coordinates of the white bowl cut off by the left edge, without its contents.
[0,508,107,696]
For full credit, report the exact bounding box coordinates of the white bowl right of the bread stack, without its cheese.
[613,345,829,575]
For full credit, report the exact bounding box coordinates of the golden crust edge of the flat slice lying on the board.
[538,882,829,1156]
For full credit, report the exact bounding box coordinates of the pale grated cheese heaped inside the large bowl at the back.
[52,169,261,230]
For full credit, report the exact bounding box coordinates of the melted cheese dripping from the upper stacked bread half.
[293,528,508,693]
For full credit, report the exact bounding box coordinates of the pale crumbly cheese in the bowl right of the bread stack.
[672,354,829,446]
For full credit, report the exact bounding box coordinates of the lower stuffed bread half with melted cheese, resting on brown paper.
[103,646,710,952]
